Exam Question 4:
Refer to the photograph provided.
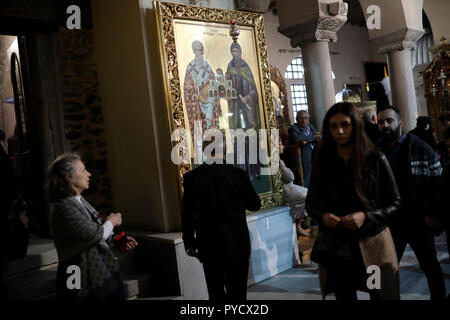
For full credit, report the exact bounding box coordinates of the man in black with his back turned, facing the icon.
[182,137,261,301]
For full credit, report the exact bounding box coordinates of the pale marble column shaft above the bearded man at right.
[387,49,419,132]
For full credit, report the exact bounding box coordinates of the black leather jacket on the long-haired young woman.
[306,149,400,263]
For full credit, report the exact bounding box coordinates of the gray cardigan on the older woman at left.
[50,197,119,297]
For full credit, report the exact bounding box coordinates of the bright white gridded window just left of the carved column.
[284,56,308,114]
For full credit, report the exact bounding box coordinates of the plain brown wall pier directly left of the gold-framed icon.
[91,0,173,232]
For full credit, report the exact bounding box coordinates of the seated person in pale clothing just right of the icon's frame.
[280,140,309,237]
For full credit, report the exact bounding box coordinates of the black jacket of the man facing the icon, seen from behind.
[182,164,261,262]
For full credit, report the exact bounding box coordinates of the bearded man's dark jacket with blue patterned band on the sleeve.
[379,134,442,225]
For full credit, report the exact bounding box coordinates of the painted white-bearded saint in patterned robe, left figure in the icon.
[184,40,222,137]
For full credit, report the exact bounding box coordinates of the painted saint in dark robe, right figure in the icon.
[227,42,260,129]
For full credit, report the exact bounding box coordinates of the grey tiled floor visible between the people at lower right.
[247,233,450,300]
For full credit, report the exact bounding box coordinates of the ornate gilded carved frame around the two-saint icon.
[153,1,283,209]
